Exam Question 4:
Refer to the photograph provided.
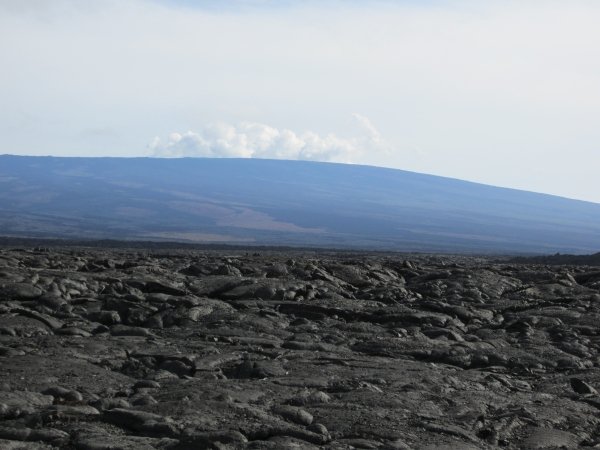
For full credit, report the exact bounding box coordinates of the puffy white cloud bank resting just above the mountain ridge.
[148,114,389,163]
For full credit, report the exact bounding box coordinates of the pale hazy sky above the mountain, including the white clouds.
[0,0,600,203]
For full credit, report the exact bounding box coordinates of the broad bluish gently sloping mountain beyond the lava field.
[0,156,600,254]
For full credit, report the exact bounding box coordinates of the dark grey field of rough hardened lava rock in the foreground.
[0,248,600,450]
